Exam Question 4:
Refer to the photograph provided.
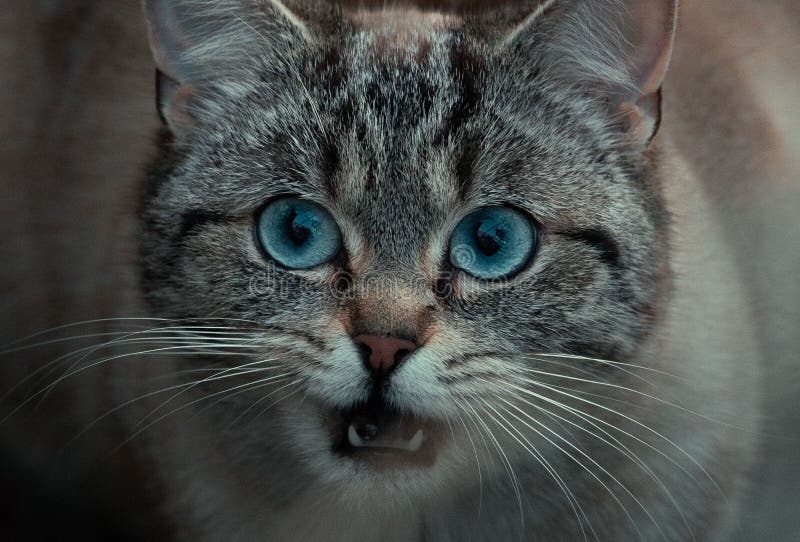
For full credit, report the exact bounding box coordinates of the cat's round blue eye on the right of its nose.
[450,207,537,280]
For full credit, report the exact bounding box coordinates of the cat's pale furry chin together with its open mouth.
[284,397,468,502]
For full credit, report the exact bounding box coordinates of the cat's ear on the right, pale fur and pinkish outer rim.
[507,0,678,150]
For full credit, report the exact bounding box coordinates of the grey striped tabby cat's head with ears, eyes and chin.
[141,1,669,500]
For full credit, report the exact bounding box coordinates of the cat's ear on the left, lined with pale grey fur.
[142,0,310,135]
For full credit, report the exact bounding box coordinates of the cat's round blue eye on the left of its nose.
[257,198,342,269]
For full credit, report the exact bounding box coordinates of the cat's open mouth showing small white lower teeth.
[331,399,441,469]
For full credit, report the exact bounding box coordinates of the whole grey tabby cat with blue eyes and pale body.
[0,0,796,541]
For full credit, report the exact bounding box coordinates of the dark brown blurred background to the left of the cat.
[0,0,164,541]
